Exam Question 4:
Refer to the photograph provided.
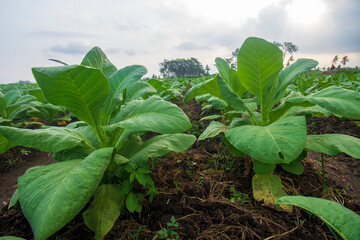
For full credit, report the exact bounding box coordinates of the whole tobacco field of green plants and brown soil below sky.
[0,37,360,240]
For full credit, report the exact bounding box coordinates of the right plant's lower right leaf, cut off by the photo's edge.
[305,134,360,158]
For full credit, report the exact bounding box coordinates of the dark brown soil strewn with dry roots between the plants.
[0,101,360,240]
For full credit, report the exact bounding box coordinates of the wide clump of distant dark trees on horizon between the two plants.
[159,58,205,78]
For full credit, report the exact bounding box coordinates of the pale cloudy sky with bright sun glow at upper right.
[0,0,360,83]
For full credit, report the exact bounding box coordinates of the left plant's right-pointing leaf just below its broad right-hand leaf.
[125,133,196,166]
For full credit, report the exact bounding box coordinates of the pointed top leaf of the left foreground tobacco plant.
[81,47,117,78]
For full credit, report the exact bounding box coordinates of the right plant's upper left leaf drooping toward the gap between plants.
[184,75,222,103]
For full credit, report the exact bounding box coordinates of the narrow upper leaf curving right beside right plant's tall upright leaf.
[269,58,319,107]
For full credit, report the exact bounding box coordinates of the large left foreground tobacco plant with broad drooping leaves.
[0,47,196,239]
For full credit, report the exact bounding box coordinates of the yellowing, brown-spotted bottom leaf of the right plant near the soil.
[252,174,292,212]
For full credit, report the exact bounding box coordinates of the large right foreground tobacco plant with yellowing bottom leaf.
[184,37,360,210]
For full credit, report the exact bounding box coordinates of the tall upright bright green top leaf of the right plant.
[237,37,283,113]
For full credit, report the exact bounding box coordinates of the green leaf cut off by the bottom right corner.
[276,196,360,240]
